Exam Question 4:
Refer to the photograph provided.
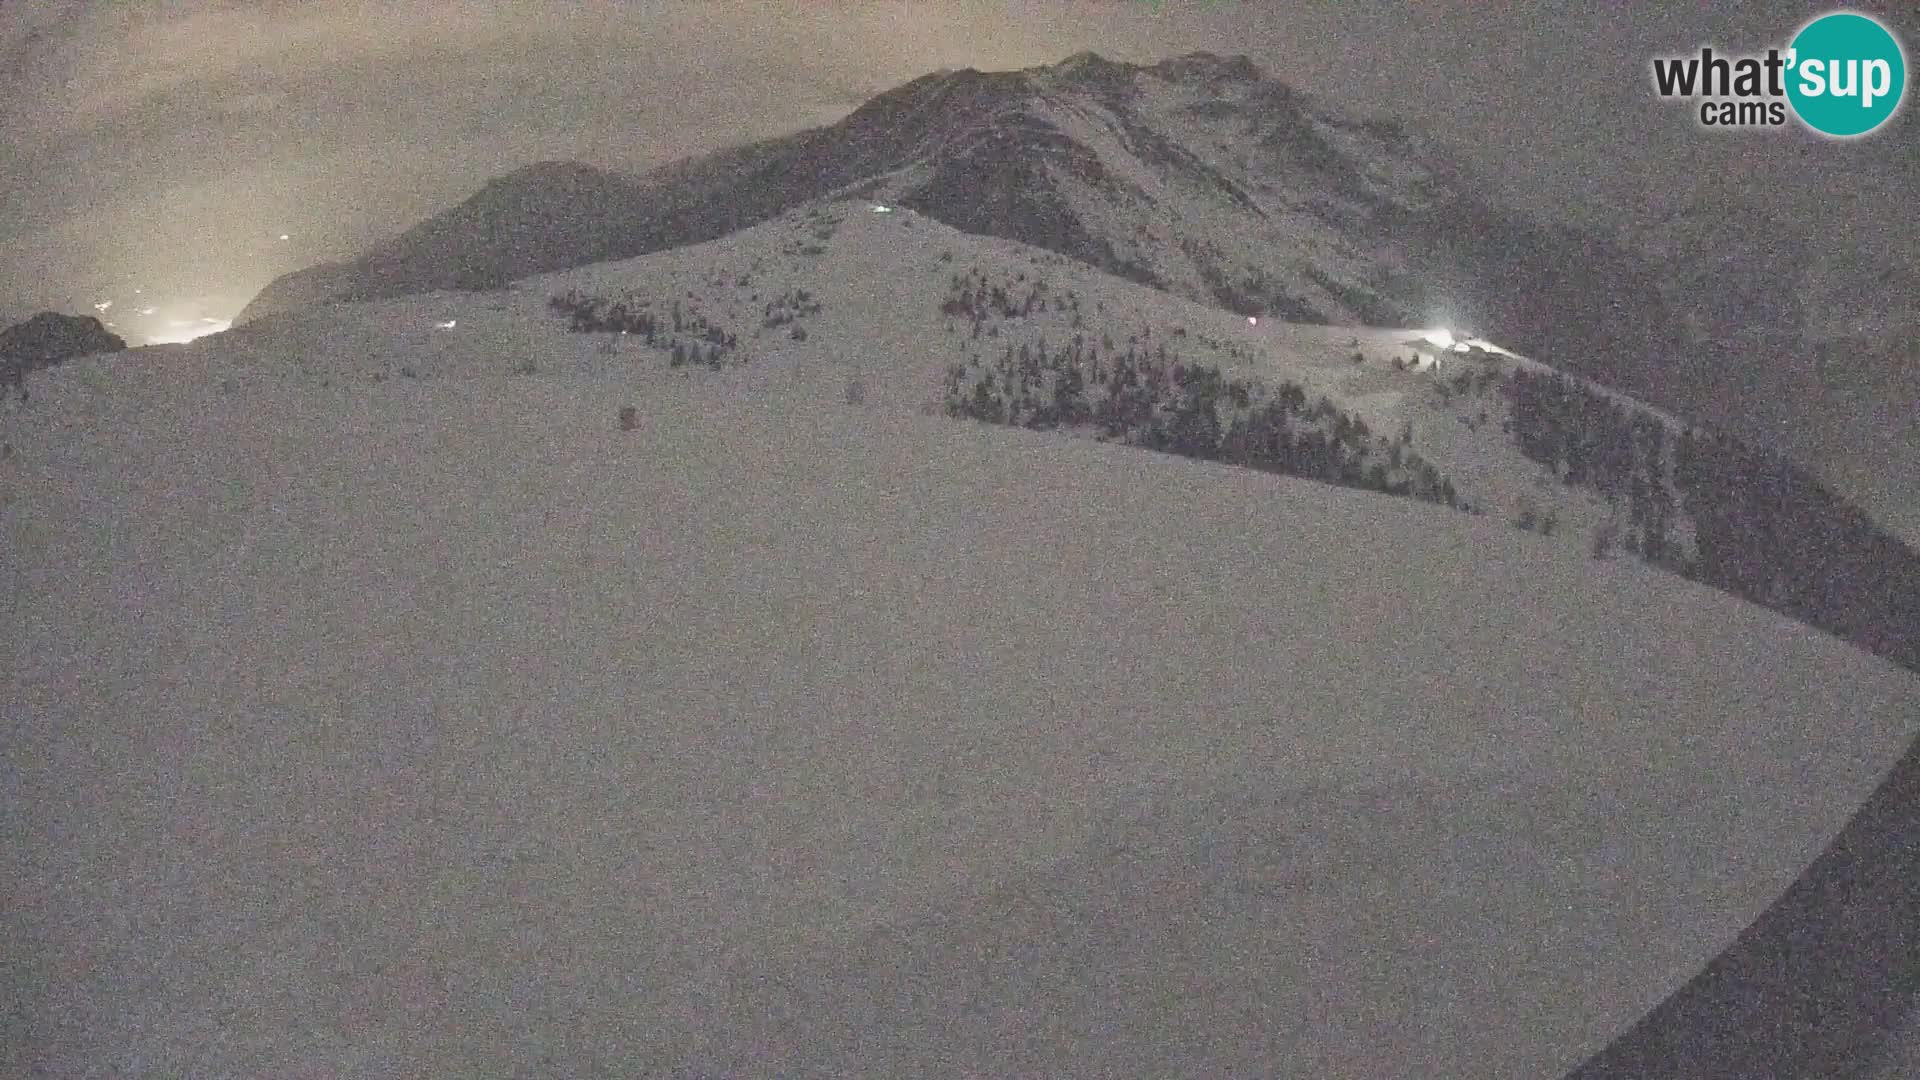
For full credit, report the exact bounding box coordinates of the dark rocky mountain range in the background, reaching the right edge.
[228,54,1920,568]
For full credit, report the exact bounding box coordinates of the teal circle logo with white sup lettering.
[1788,12,1907,138]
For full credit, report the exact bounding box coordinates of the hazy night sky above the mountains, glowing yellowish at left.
[0,0,1920,334]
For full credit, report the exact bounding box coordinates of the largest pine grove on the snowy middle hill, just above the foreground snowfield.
[945,334,1467,509]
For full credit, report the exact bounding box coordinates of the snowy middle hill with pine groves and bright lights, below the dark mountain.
[219,191,1920,665]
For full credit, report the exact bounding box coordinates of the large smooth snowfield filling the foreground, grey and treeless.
[0,365,1916,1078]
